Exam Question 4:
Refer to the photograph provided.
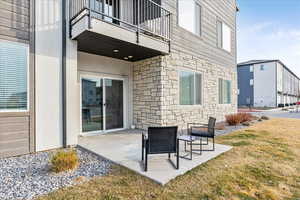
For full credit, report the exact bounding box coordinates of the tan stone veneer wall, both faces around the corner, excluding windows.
[133,51,237,129]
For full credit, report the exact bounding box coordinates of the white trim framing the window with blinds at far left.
[0,40,30,113]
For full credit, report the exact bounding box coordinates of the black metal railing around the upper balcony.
[69,0,171,41]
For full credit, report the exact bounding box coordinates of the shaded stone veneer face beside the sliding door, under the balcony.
[133,56,163,129]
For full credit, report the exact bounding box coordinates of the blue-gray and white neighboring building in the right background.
[238,60,300,107]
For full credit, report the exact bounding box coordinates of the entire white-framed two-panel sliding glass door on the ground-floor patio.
[81,77,124,133]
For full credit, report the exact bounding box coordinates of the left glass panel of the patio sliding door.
[81,78,103,132]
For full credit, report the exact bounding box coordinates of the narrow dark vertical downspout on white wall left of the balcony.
[61,0,67,148]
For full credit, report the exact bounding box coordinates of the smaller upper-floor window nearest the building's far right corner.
[217,20,231,52]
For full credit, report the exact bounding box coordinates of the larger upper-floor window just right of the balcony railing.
[178,0,202,36]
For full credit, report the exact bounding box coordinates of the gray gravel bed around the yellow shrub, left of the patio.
[0,148,111,200]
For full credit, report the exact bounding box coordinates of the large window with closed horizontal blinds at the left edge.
[0,41,28,111]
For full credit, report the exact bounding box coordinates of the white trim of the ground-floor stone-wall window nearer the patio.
[177,68,204,108]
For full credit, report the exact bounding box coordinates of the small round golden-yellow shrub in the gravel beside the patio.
[51,150,79,173]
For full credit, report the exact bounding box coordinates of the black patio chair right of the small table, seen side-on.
[187,117,216,151]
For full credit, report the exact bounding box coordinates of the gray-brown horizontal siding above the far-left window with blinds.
[0,0,30,43]
